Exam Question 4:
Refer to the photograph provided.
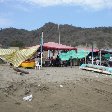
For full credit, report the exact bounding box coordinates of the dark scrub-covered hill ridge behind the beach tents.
[0,22,112,48]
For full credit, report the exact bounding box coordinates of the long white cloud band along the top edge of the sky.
[21,0,112,9]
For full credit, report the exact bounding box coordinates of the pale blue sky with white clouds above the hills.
[0,0,112,30]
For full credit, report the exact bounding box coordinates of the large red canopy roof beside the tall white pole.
[43,42,77,50]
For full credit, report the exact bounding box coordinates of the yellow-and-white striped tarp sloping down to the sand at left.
[0,45,40,67]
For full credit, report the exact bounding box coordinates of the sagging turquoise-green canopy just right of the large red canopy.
[59,50,90,60]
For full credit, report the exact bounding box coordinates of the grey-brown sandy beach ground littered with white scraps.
[0,64,112,112]
